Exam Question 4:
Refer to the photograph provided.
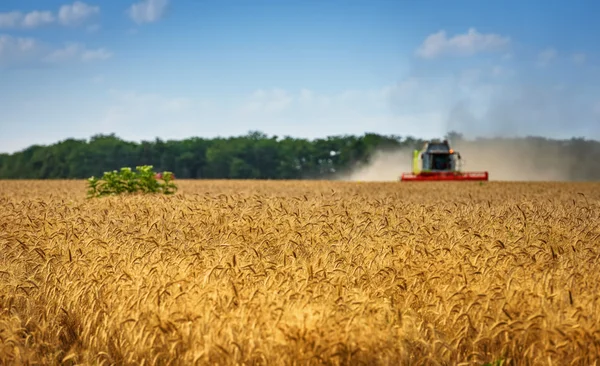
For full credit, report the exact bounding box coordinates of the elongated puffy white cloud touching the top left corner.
[0,1,100,29]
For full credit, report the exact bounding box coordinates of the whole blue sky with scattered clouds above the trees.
[0,0,600,152]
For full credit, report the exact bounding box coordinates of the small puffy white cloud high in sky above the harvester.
[416,28,510,59]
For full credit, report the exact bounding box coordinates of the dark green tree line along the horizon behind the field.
[0,131,600,180]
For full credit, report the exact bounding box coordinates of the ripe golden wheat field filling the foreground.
[0,181,600,365]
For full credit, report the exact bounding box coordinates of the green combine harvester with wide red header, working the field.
[400,140,489,182]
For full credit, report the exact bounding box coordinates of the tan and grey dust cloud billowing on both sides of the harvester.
[342,69,600,182]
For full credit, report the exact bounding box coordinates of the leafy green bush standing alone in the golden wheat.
[87,165,177,198]
